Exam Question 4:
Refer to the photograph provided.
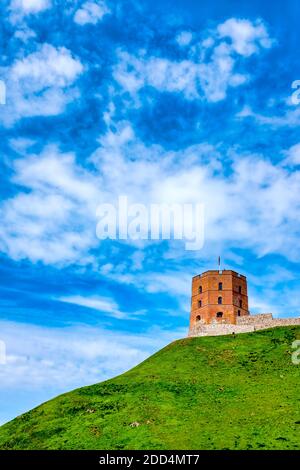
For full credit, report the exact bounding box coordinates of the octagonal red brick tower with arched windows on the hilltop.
[190,269,249,331]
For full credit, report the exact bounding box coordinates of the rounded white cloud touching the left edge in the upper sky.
[0,44,83,125]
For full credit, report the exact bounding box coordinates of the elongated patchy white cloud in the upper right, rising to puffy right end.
[114,18,272,103]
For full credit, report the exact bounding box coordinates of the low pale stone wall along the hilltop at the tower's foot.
[188,313,300,336]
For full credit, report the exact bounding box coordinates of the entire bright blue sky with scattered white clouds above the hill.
[0,0,300,422]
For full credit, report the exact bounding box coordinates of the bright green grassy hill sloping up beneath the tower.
[0,327,300,450]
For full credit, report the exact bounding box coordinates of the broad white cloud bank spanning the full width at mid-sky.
[0,122,300,270]
